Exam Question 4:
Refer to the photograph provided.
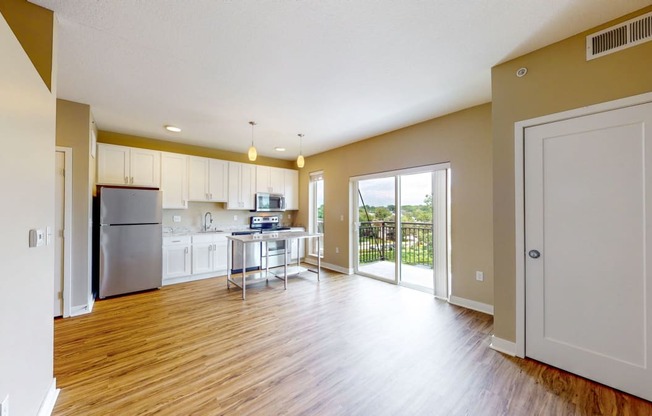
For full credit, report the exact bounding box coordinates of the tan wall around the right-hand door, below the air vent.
[492,7,652,341]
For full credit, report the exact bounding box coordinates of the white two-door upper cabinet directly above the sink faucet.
[188,156,229,202]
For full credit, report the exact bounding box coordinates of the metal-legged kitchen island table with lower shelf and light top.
[226,231,323,300]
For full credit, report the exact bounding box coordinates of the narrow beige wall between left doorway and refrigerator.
[56,100,95,308]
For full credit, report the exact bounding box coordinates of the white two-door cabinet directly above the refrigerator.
[97,143,161,188]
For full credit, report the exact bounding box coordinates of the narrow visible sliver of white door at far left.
[54,151,66,316]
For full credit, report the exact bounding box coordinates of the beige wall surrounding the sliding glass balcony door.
[297,104,493,305]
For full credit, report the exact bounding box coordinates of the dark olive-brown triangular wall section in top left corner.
[0,0,54,90]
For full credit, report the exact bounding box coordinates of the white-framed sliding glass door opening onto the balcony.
[352,164,449,298]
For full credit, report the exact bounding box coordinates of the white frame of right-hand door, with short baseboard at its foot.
[512,92,652,358]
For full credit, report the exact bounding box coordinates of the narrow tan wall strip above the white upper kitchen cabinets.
[97,130,297,169]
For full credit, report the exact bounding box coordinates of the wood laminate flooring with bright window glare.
[54,273,652,416]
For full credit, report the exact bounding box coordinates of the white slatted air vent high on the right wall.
[586,12,652,61]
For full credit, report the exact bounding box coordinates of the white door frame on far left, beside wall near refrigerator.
[55,146,73,318]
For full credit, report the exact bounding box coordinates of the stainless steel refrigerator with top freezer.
[98,186,163,299]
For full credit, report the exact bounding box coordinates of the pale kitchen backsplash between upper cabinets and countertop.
[163,202,296,231]
